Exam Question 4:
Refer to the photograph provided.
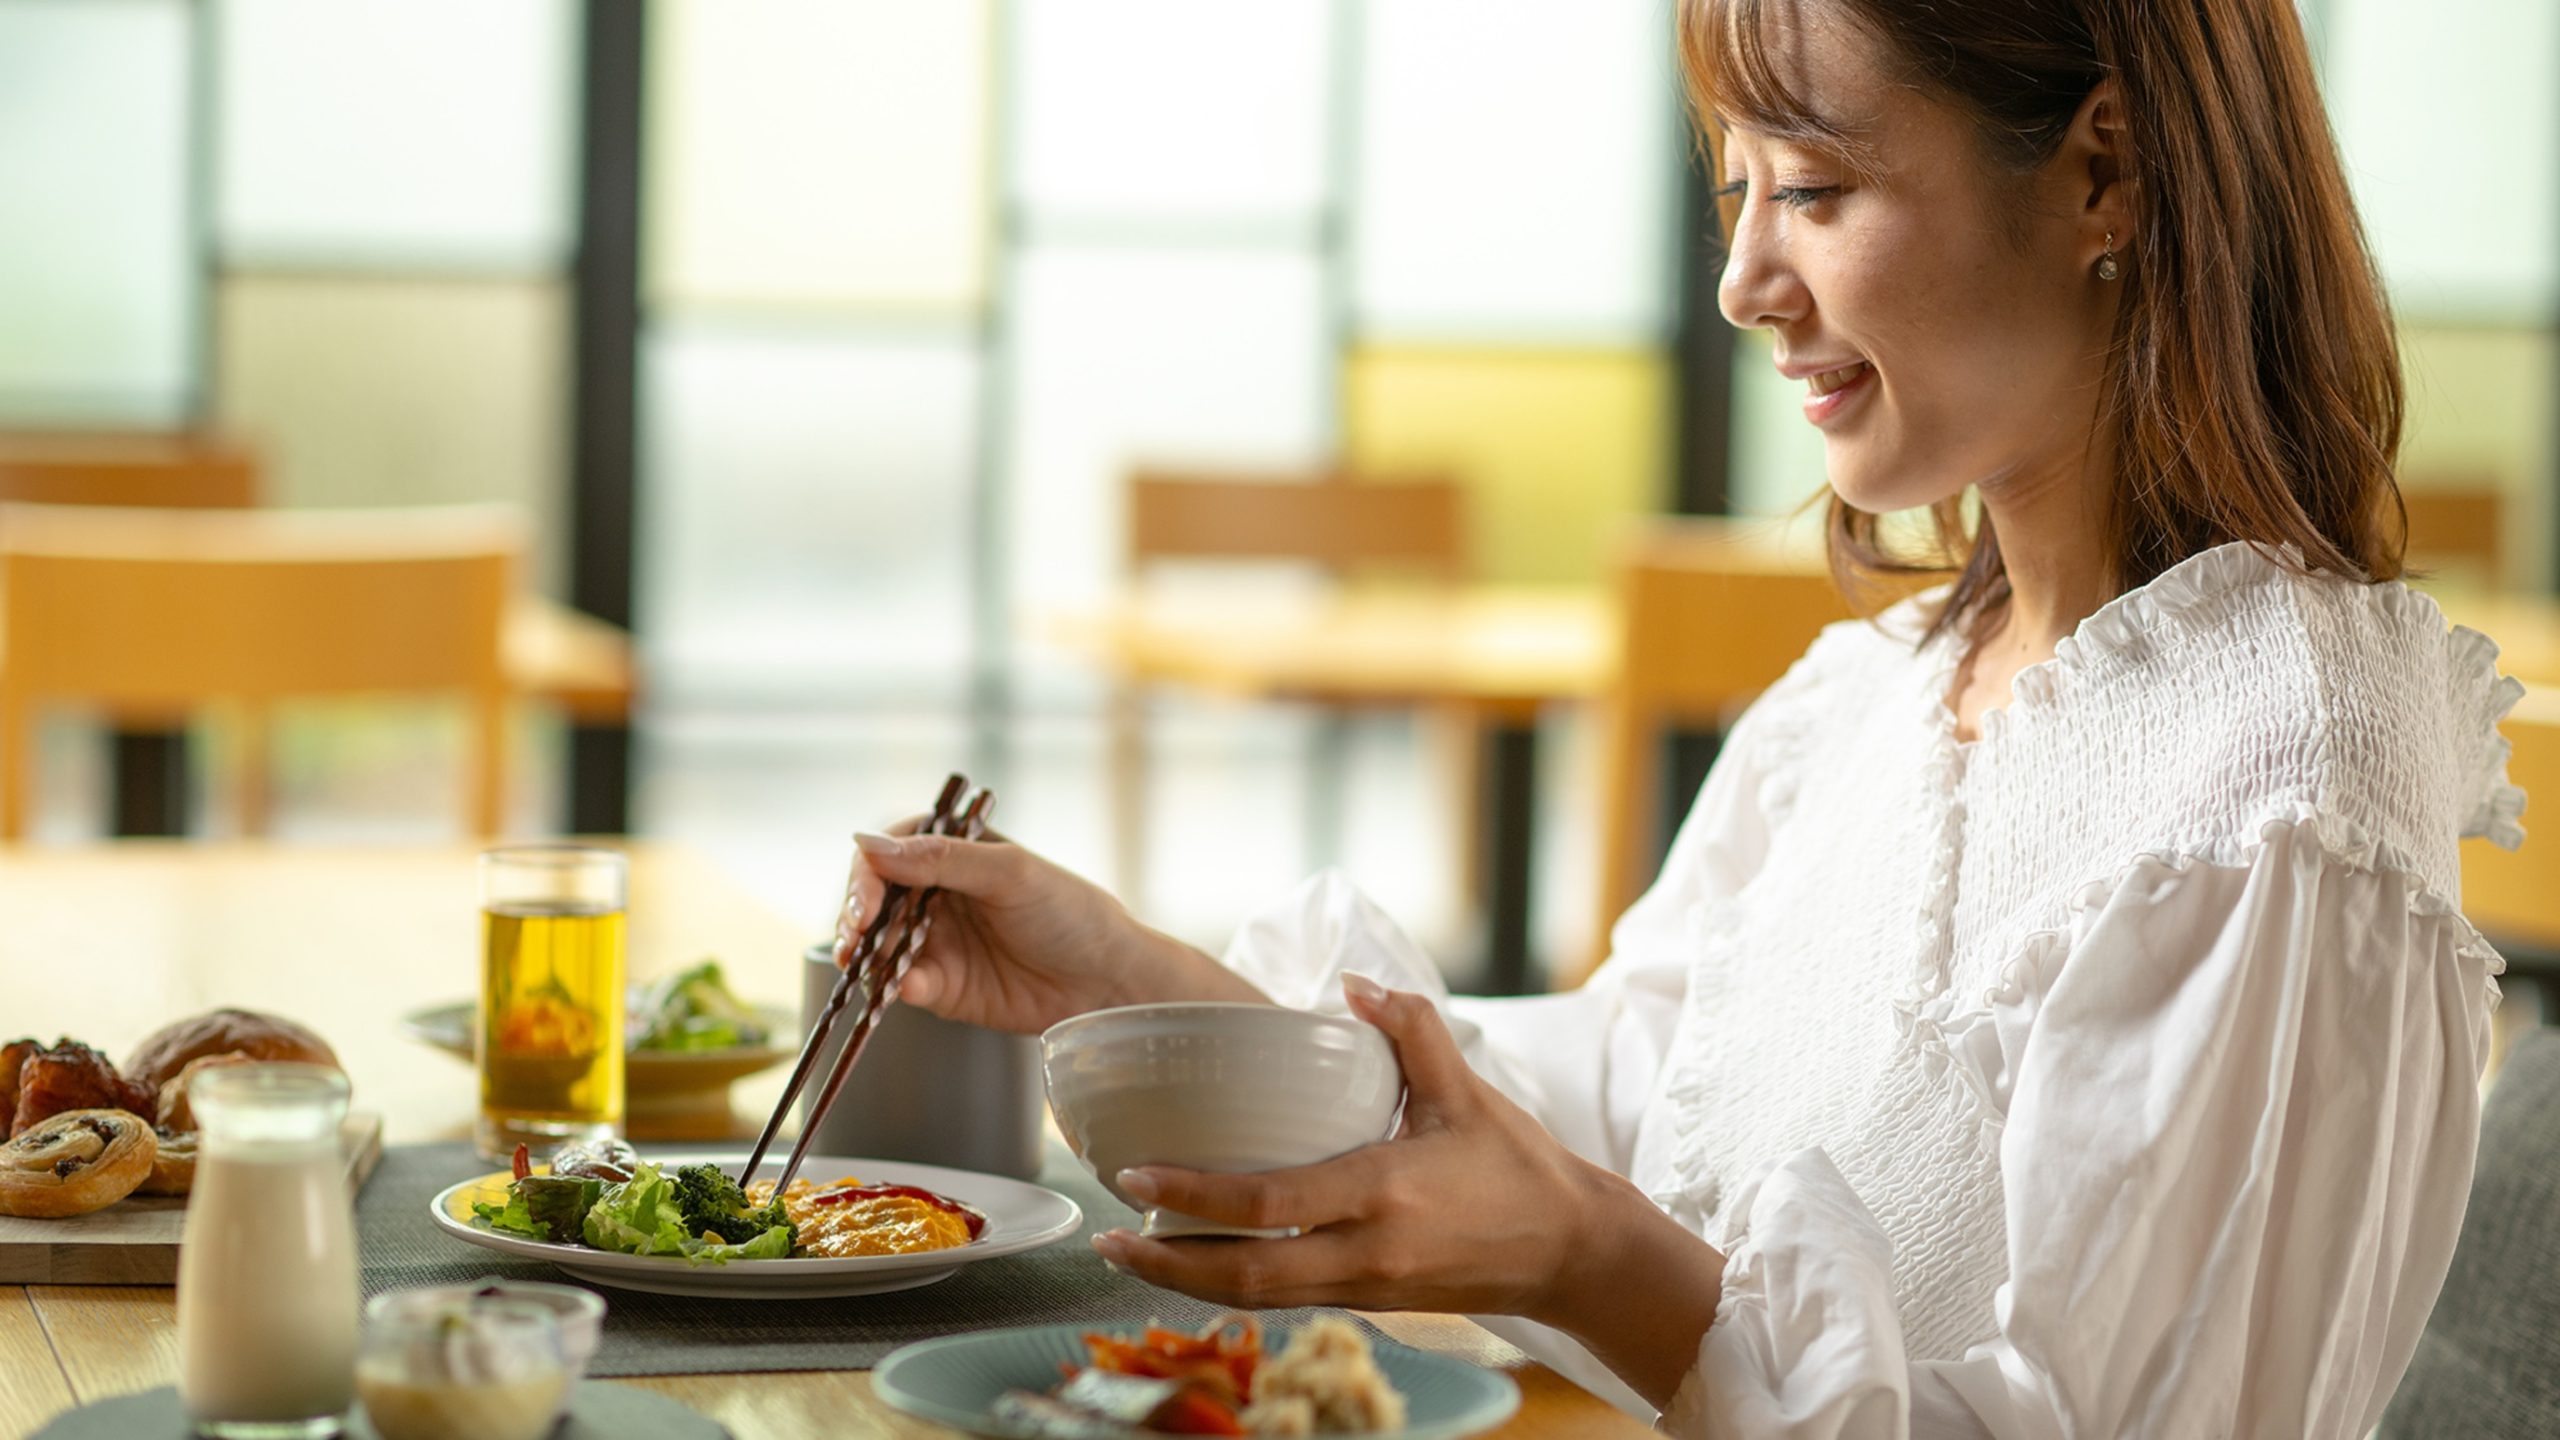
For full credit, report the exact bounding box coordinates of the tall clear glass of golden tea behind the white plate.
[474,846,630,1158]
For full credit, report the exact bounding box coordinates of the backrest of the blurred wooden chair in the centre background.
[1129,469,1467,579]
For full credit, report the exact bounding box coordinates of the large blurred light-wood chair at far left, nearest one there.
[0,505,527,840]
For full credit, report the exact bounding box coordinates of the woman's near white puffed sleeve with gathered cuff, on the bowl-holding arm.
[1664,817,2499,1440]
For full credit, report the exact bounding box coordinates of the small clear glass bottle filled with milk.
[177,1063,356,1440]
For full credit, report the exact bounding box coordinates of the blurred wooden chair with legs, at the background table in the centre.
[1108,466,1475,904]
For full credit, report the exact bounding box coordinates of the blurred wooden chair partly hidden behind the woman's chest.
[1559,518,1851,984]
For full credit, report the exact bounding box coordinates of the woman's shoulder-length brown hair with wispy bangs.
[1679,0,2406,638]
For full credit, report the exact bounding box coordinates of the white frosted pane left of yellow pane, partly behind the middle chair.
[1006,246,1334,671]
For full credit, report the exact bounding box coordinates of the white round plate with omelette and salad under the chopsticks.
[430,1143,1083,1297]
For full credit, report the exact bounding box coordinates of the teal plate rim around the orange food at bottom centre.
[870,1325,1521,1440]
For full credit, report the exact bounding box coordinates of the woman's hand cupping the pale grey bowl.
[1093,976,1659,1320]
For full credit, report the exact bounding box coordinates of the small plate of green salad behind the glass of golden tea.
[399,961,799,1140]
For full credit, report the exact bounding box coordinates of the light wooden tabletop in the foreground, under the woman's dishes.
[0,843,1649,1440]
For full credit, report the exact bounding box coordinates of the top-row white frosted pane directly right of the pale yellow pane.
[1009,0,1334,223]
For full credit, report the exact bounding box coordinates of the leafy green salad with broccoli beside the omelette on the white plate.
[471,1161,794,1266]
